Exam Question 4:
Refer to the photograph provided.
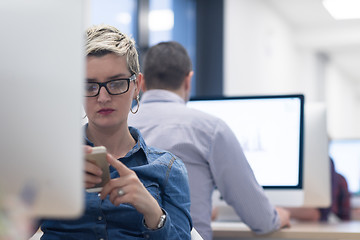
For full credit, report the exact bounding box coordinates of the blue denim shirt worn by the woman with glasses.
[41,125,192,240]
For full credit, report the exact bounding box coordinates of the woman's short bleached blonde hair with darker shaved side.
[86,24,140,75]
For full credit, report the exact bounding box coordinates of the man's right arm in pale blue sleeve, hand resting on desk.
[209,120,289,234]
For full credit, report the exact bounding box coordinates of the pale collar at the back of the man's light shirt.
[141,89,185,104]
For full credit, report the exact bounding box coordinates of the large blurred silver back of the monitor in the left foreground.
[0,0,86,218]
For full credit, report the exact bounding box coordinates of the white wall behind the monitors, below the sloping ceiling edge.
[224,0,360,138]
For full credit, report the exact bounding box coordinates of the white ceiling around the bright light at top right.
[265,0,360,80]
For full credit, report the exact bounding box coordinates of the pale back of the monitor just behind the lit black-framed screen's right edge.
[304,102,331,208]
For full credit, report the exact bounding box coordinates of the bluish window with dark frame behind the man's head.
[91,0,223,96]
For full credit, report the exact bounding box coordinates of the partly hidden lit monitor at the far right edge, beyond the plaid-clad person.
[329,139,360,208]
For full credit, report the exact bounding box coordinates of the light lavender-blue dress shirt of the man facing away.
[128,90,280,240]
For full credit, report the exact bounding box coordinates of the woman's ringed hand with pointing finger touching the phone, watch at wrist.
[100,154,163,229]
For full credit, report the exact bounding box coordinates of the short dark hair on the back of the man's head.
[143,41,192,90]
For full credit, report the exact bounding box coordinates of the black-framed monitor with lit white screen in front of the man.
[188,94,304,207]
